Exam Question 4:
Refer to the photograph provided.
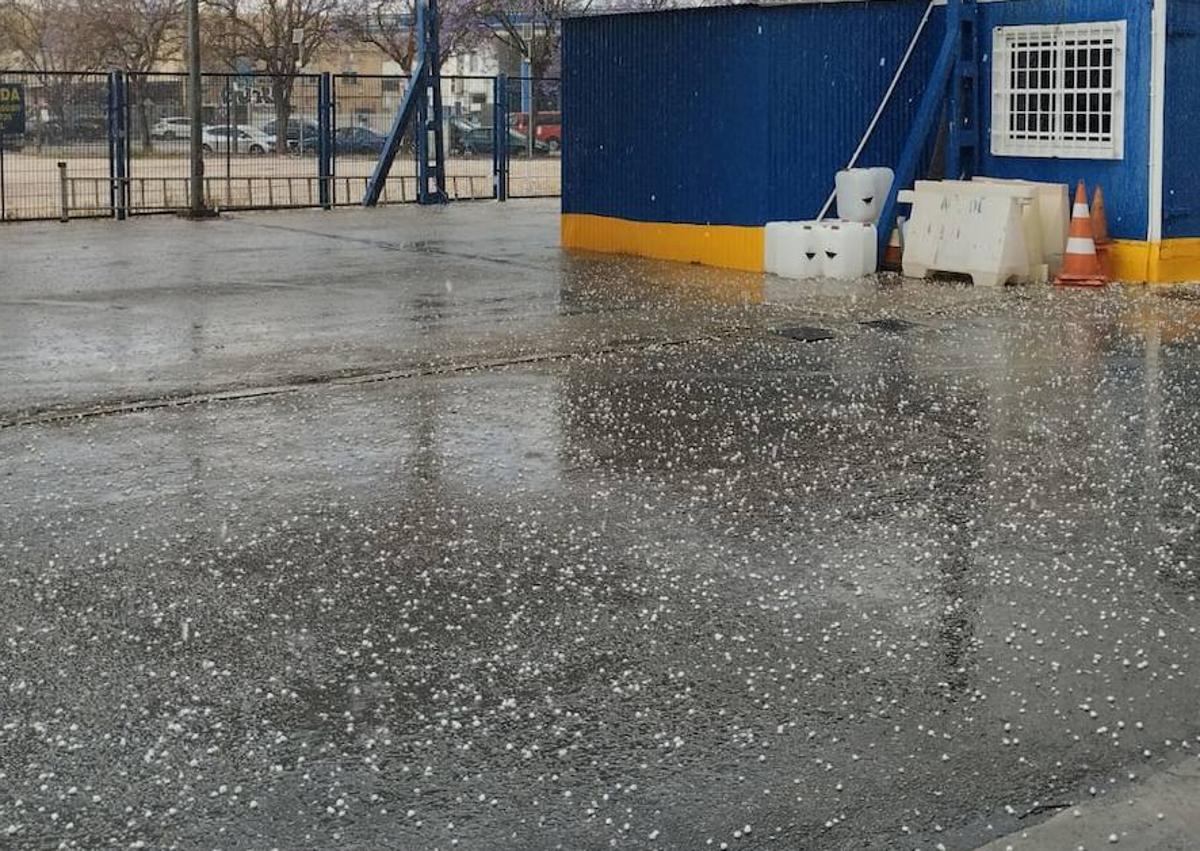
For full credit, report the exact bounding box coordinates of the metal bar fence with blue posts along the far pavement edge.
[0,71,562,221]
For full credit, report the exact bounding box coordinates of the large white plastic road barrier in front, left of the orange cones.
[900,180,1045,286]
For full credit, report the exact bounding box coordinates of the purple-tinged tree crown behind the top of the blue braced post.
[338,0,485,74]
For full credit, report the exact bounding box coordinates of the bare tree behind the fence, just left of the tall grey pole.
[80,0,184,150]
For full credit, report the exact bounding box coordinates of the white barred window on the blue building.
[991,20,1126,160]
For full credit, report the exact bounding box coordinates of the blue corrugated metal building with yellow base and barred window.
[563,0,1200,280]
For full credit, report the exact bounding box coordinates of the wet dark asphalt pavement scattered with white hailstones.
[0,203,1200,849]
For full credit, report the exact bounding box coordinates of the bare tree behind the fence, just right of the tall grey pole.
[204,0,337,152]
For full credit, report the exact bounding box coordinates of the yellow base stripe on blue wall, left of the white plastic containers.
[562,212,764,271]
